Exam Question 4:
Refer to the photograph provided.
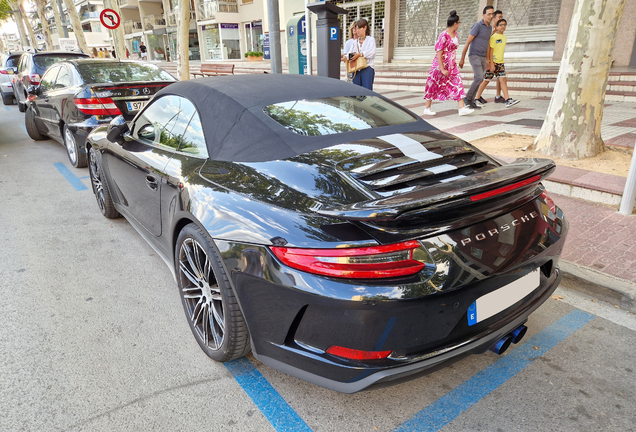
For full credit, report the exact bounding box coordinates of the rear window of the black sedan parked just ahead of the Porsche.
[77,61,175,84]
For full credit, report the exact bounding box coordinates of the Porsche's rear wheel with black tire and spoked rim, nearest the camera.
[175,224,251,362]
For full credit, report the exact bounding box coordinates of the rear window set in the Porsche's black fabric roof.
[264,96,417,136]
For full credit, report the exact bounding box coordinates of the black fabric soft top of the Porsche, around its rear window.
[156,74,434,162]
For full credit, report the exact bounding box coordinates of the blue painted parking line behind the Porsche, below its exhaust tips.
[394,309,594,432]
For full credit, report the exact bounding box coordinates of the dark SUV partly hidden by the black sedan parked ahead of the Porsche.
[13,50,90,112]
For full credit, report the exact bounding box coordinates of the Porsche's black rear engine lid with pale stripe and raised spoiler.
[200,131,555,221]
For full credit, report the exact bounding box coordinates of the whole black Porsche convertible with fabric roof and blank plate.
[86,75,567,393]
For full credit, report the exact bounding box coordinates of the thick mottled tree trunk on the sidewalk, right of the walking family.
[532,0,625,160]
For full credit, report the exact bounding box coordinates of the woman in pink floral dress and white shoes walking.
[424,11,473,115]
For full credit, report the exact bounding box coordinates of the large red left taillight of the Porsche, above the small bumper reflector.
[270,240,434,279]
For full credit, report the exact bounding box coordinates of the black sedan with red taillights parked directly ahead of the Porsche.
[24,59,175,168]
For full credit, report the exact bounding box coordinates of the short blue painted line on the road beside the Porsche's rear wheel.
[224,357,311,431]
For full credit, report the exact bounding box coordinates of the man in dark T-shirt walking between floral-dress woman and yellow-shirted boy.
[459,6,495,109]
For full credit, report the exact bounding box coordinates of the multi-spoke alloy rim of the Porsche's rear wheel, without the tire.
[178,237,225,351]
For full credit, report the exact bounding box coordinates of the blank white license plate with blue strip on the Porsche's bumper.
[468,269,541,326]
